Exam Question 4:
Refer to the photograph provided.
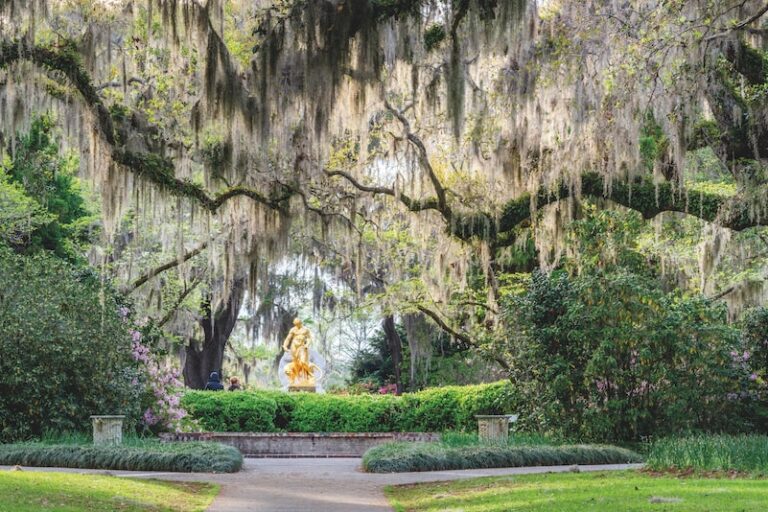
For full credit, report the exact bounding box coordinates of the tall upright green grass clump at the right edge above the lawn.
[647,435,768,472]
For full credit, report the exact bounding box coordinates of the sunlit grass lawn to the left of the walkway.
[0,471,219,512]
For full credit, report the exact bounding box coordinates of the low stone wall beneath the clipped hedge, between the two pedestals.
[160,432,440,457]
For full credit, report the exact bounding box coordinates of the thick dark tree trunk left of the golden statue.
[184,279,245,389]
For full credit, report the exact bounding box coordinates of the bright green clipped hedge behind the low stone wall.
[182,382,517,432]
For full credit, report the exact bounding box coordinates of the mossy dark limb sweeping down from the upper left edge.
[0,40,293,212]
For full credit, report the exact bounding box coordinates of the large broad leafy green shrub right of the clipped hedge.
[504,268,744,440]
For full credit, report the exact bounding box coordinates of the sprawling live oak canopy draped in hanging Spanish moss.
[0,0,768,382]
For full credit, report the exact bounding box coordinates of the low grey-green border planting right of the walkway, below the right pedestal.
[363,443,643,473]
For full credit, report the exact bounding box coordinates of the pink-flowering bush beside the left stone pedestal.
[119,308,187,432]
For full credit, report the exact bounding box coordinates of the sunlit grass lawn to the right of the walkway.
[386,471,768,512]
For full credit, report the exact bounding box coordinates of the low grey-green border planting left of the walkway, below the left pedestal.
[0,442,243,473]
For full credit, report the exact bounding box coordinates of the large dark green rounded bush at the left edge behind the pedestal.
[0,248,139,441]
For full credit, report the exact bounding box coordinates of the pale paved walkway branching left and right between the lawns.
[0,459,641,512]
